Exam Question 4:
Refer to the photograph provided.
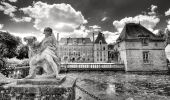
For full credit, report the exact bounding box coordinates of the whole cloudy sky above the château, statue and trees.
[0,0,170,43]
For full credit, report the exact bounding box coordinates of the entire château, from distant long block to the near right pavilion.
[58,23,168,71]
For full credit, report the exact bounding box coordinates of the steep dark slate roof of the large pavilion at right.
[116,23,164,42]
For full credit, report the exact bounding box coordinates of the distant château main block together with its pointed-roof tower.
[58,32,108,63]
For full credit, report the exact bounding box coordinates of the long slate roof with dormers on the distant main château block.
[59,38,92,44]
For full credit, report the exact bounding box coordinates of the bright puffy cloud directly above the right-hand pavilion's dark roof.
[113,15,160,32]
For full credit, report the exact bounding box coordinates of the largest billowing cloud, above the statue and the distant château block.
[20,1,87,32]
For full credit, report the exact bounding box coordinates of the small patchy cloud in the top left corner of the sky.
[0,2,17,17]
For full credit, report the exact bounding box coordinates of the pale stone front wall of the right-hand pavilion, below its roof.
[124,42,167,71]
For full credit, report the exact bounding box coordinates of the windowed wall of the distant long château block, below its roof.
[58,44,93,63]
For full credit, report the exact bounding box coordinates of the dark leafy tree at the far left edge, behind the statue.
[0,32,21,75]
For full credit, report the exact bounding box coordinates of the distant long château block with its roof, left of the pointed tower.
[58,38,93,63]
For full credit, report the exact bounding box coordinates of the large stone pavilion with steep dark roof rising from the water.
[114,23,168,71]
